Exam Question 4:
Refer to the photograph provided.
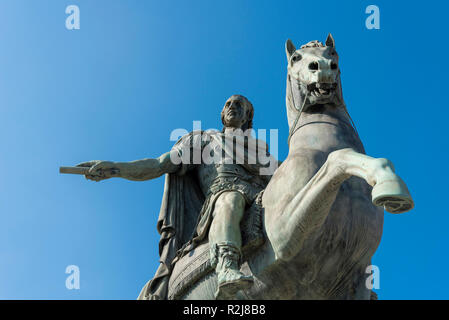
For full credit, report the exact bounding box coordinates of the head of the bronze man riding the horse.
[221,94,254,131]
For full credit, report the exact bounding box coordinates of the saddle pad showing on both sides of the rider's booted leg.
[168,191,266,300]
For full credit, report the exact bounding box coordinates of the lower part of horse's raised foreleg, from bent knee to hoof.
[333,148,414,213]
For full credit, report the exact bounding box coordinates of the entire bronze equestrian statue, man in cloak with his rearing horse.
[60,34,414,299]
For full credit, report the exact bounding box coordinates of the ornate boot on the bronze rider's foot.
[211,242,254,300]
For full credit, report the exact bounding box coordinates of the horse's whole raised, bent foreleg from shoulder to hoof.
[265,148,413,260]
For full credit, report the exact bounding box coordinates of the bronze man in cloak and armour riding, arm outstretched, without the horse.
[61,95,271,299]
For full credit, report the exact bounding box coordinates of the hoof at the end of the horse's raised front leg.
[371,176,414,213]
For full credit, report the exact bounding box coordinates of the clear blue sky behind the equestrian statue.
[0,0,449,299]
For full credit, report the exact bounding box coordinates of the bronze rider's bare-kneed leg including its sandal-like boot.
[209,191,253,299]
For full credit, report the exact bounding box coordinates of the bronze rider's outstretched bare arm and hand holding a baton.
[77,152,180,181]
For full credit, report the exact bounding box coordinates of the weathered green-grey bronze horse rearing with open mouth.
[166,35,413,299]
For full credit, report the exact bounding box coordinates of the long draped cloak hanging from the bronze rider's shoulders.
[138,131,278,300]
